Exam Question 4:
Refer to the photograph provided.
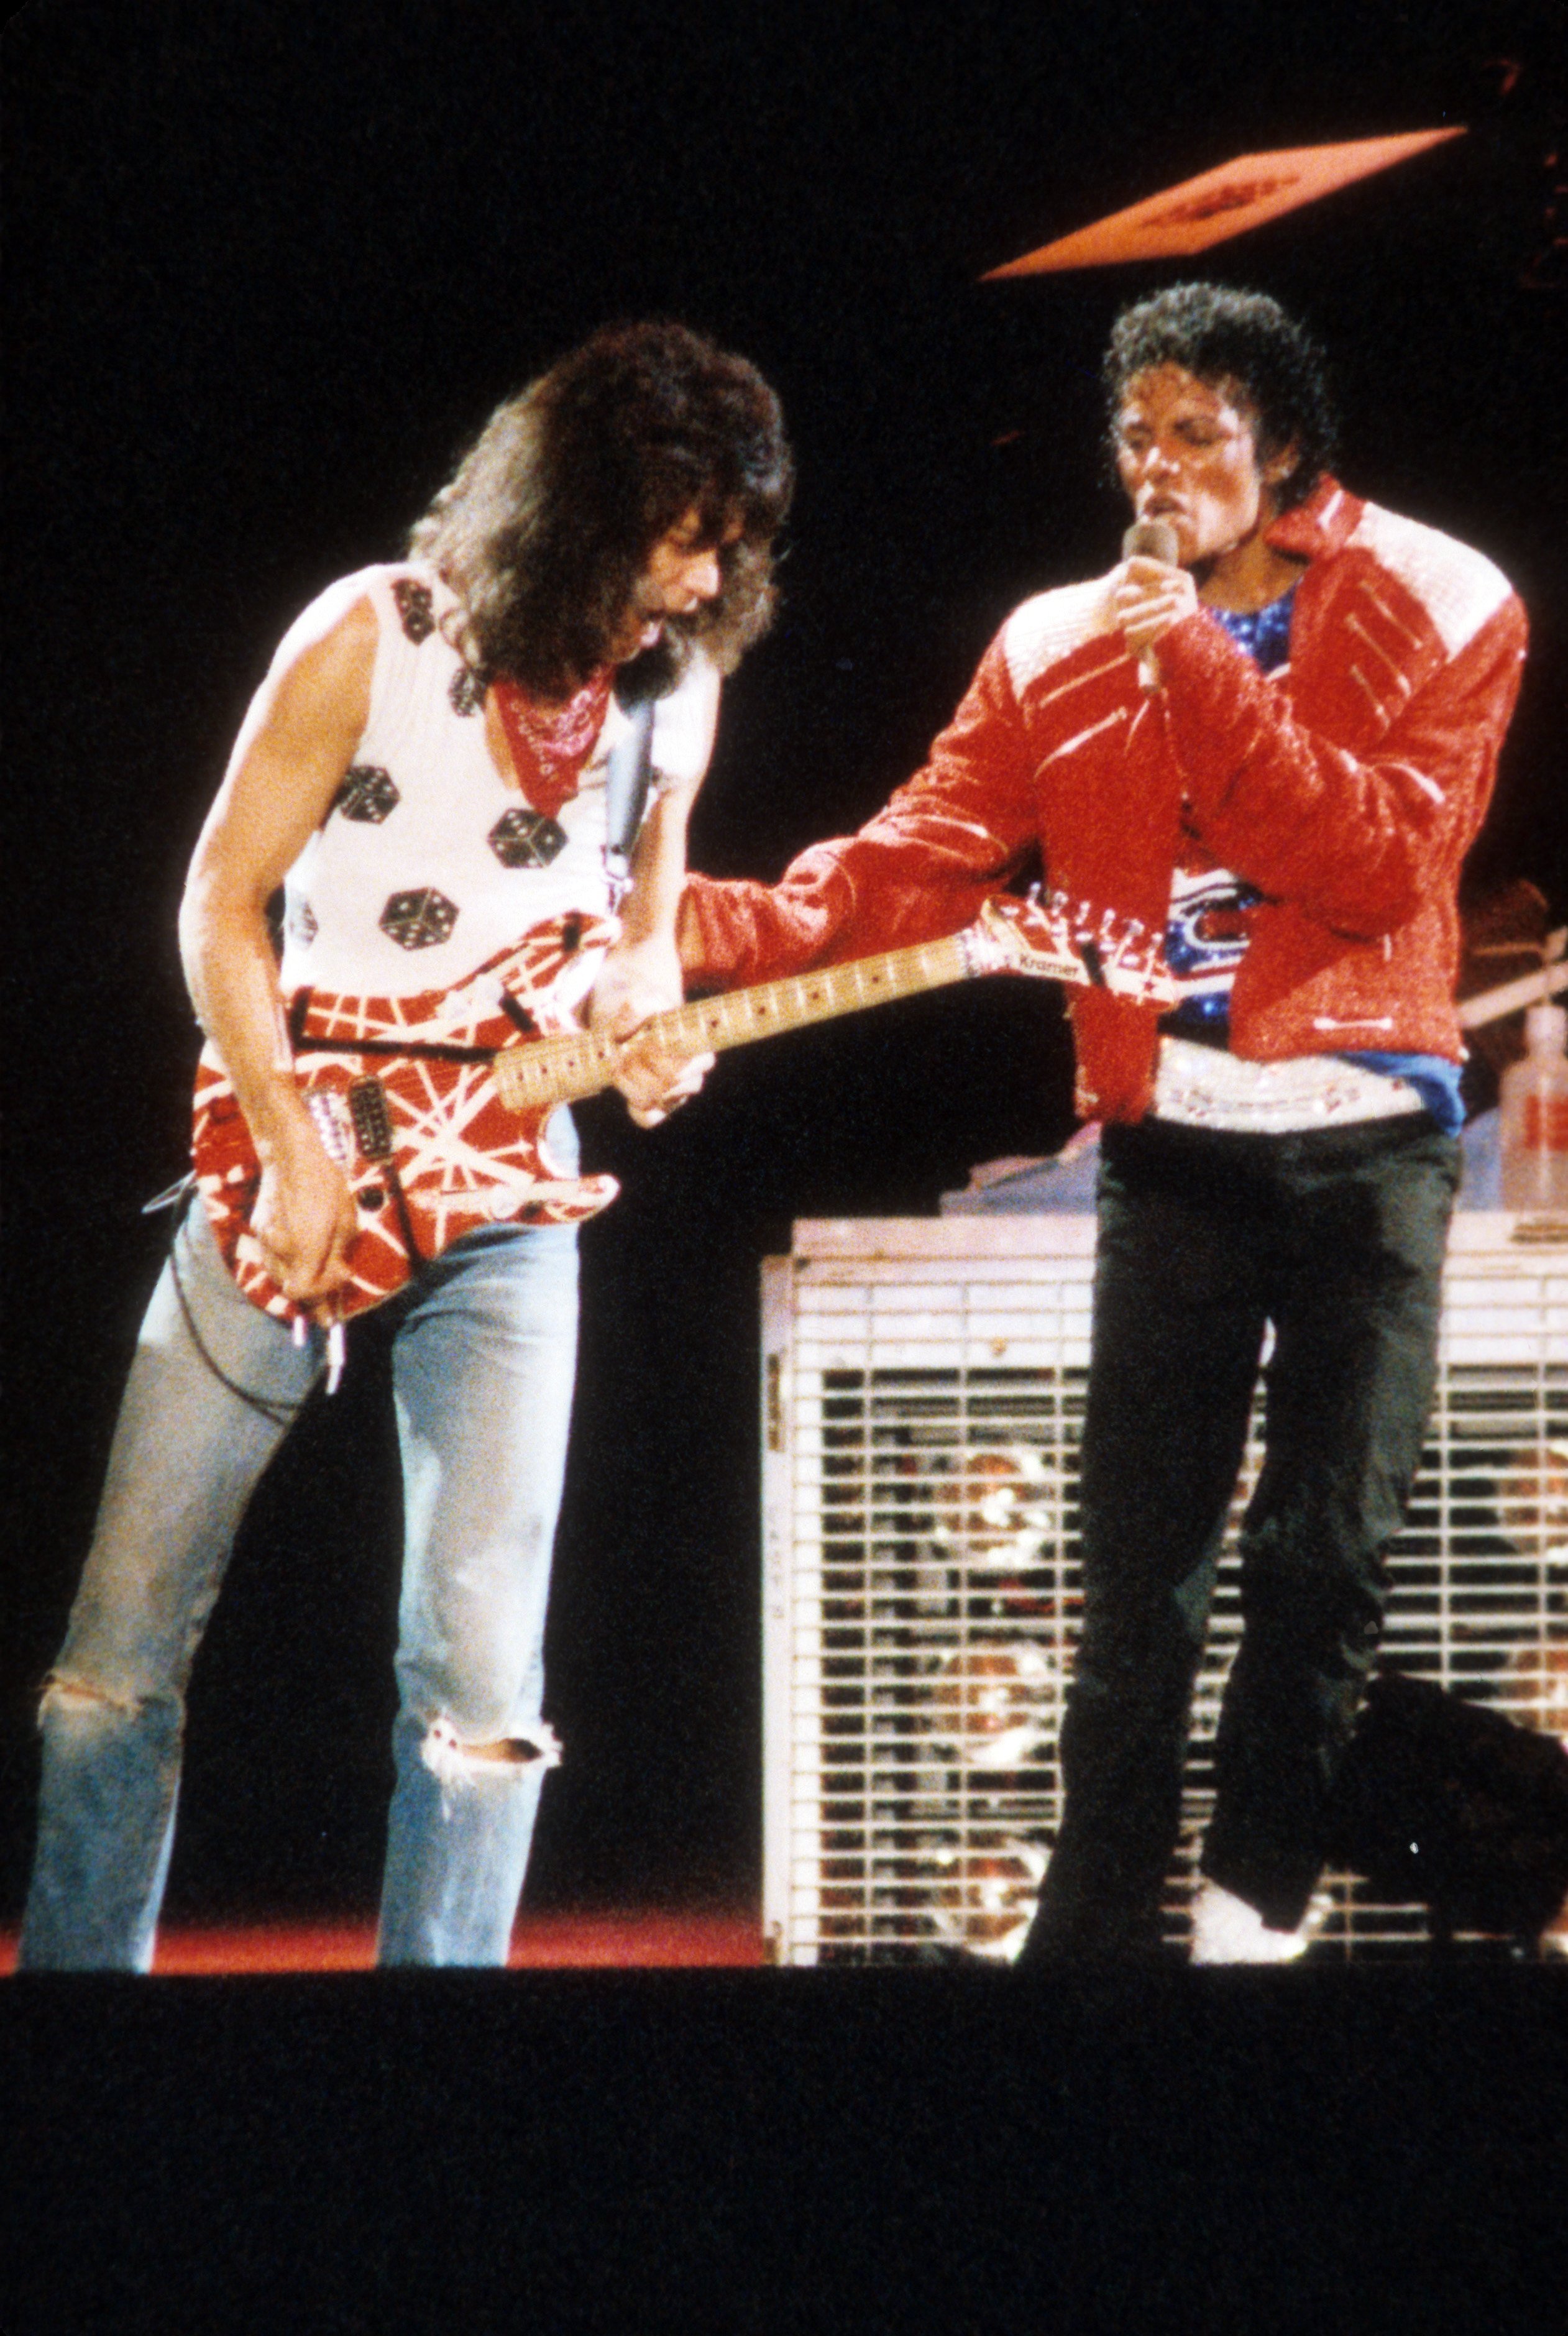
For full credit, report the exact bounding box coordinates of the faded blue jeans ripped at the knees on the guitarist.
[19,1186,577,1972]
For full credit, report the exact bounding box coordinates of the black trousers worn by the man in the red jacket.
[1021,1112,1458,1963]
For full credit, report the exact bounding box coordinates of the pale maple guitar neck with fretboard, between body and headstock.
[495,932,974,1112]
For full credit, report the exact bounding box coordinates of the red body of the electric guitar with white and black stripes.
[191,916,619,1320]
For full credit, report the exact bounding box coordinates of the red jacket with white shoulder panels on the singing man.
[680,479,1526,1119]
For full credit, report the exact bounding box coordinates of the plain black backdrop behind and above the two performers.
[0,0,1568,1918]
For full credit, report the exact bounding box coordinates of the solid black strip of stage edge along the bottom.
[0,1963,1568,2336]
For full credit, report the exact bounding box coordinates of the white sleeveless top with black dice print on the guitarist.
[280,563,720,997]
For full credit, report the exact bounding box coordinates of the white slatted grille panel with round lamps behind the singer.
[764,1217,1568,1963]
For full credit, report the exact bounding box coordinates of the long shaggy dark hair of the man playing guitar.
[409,323,794,699]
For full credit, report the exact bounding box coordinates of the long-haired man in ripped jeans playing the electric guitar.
[21,325,790,1969]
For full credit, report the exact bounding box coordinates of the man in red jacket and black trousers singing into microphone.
[680,285,1526,1963]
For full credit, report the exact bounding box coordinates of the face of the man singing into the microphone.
[1117,364,1281,567]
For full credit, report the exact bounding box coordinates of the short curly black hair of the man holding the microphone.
[1101,285,1339,511]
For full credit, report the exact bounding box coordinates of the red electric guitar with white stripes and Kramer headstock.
[191,897,1173,1320]
